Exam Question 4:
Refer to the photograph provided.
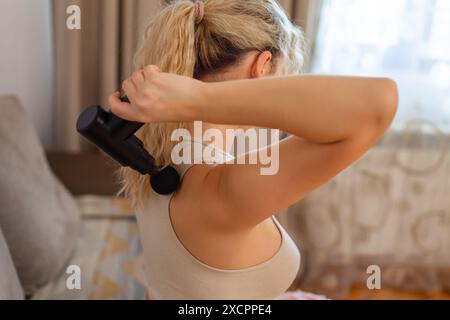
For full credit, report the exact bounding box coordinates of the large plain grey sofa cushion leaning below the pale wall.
[0,96,80,295]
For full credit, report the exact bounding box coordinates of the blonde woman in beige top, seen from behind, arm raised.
[110,0,397,299]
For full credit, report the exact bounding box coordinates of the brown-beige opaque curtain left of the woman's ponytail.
[53,0,160,152]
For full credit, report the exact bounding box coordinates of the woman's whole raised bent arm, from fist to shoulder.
[110,68,398,228]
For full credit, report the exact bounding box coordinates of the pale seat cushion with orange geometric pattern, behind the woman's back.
[33,196,147,300]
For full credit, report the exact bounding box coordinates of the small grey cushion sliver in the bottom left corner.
[0,229,24,300]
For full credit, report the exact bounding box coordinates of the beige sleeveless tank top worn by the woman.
[137,140,300,300]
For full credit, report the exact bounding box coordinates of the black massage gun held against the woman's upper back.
[77,96,180,195]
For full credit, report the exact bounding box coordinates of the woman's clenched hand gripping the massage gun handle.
[109,66,203,123]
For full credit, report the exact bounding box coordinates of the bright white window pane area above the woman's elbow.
[313,0,450,133]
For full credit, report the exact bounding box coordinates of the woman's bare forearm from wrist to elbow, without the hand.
[199,76,397,143]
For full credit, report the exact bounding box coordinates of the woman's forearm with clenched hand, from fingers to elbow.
[110,70,397,143]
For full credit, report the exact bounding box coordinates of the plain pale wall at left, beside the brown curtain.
[0,0,54,149]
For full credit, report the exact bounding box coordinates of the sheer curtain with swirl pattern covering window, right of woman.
[287,0,450,297]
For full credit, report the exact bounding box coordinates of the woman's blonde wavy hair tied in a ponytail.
[119,0,304,206]
